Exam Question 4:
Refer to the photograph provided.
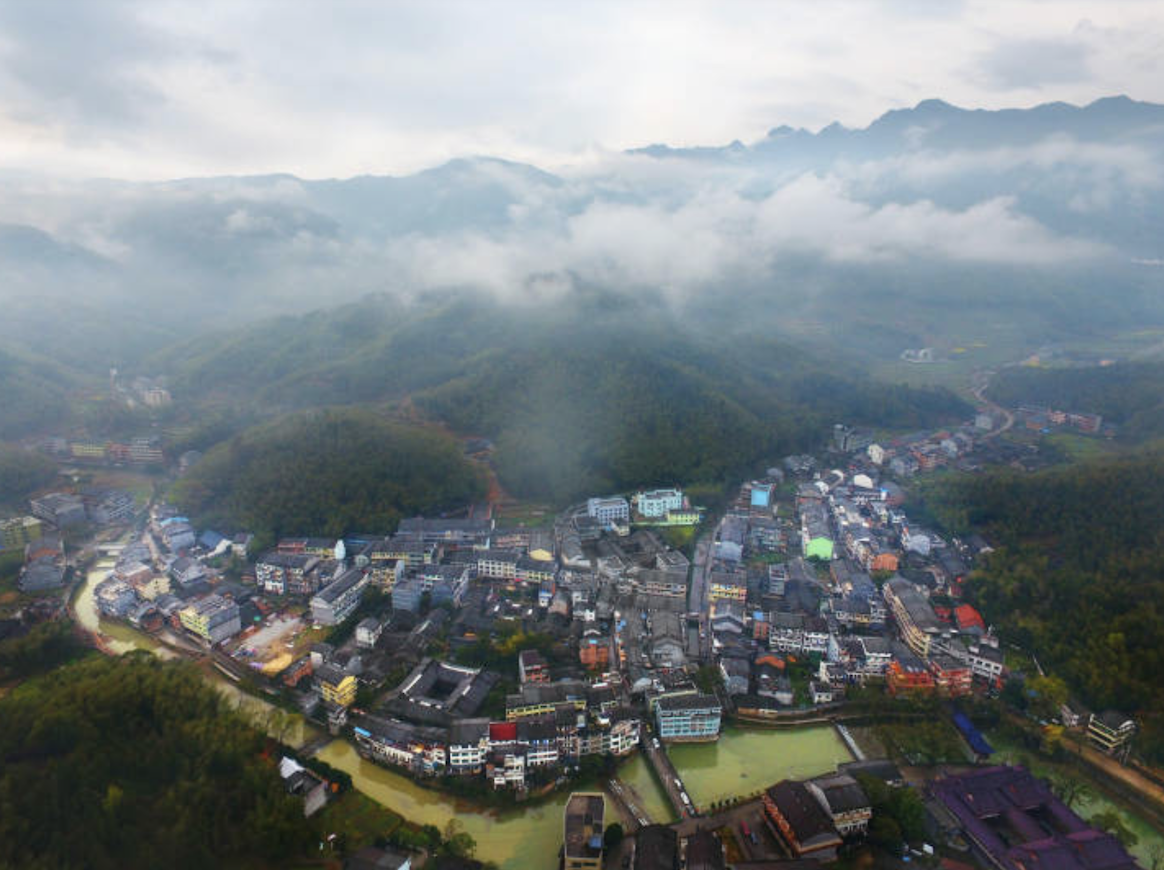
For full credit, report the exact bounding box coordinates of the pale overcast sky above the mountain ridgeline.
[0,0,1164,181]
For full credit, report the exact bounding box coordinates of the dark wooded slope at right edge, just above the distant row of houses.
[989,362,1164,441]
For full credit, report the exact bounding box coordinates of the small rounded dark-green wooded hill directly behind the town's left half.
[171,409,485,539]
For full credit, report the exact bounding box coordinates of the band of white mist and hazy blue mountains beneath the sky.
[0,97,1164,370]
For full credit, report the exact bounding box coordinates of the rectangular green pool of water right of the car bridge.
[668,726,853,808]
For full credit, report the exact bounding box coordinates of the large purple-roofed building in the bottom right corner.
[930,766,1138,870]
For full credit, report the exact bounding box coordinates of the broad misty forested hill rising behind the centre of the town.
[155,292,971,501]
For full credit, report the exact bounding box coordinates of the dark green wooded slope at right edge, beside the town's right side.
[930,446,1164,761]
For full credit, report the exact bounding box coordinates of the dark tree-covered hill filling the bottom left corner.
[0,653,311,870]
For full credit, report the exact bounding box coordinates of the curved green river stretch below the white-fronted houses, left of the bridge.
[317,740,579,870]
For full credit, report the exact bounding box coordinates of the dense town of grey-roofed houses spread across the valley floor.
[3,402,1135,868]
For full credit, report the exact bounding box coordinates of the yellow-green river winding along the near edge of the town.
[73,568,850,870]
